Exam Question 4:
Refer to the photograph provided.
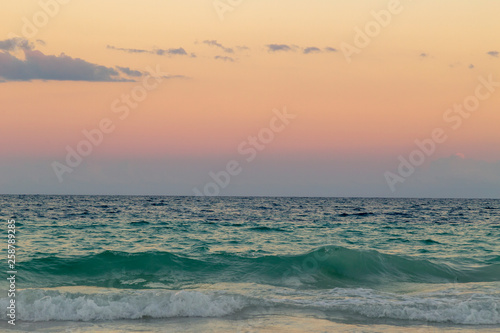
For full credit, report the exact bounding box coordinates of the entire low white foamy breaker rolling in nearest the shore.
[0,288,500,325]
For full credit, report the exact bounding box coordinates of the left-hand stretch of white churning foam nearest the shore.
[0,289,245,321]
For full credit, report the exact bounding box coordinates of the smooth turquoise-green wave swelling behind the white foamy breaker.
[19,246,500,289]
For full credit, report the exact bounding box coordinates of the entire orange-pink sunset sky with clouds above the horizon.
[0,0,500,198]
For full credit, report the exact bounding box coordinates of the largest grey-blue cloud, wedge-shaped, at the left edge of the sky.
[0,38,130,82]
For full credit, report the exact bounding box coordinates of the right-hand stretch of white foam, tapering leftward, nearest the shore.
[275,288,500,325]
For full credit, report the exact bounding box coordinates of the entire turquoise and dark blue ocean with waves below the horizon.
[0,195,500,332]
